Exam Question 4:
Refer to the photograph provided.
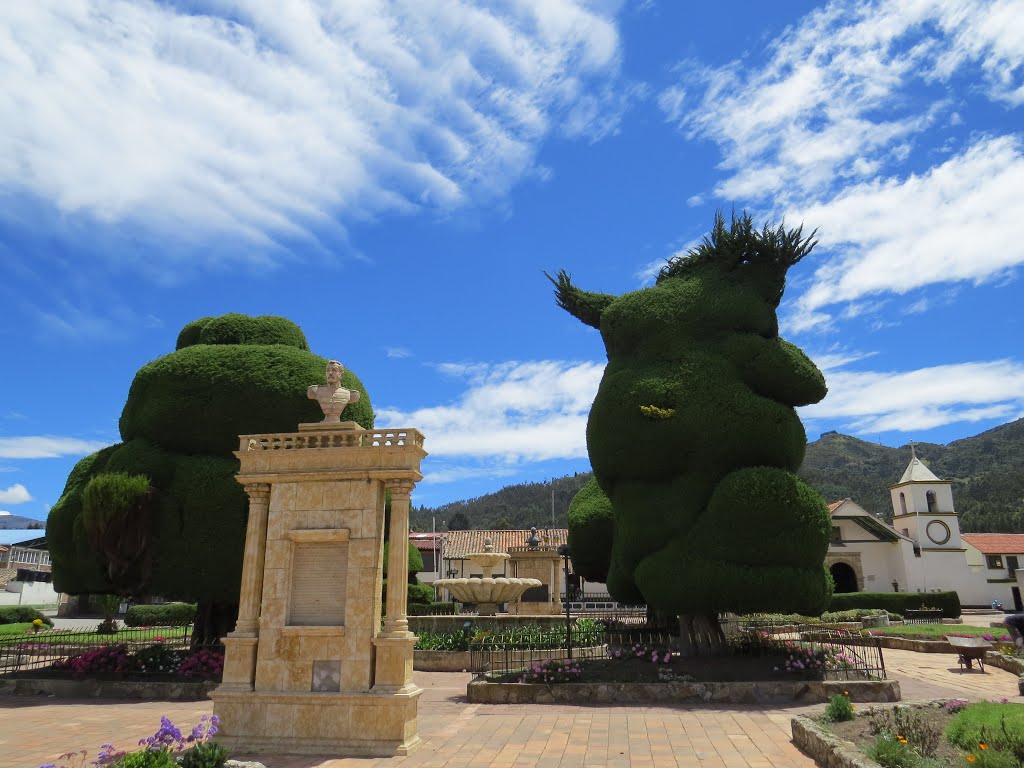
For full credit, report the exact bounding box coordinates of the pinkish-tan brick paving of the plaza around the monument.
[0,650,1024,768]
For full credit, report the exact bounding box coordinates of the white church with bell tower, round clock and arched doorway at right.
[825,446,1024,610]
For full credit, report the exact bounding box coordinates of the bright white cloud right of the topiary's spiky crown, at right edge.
[787,137,1024,330]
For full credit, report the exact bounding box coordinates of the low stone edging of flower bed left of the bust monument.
[0,678,220,701]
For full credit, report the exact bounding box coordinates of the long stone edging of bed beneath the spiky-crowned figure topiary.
[466,680,900,705]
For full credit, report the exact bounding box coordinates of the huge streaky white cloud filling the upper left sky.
[0,0,632,268]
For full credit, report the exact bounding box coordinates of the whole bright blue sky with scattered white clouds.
[0,0,1024,518]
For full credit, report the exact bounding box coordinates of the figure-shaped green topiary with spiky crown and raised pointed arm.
[552,215,830,645]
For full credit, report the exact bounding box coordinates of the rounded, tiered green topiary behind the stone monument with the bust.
[46,314,374,636]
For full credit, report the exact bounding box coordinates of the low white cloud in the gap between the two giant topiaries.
[377,360,604,463]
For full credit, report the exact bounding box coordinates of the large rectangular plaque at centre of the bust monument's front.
[288,542,348,627]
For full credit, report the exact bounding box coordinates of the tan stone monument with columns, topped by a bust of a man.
[211,361,426,757]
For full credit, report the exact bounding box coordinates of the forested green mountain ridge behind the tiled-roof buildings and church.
[411,419,1024,534]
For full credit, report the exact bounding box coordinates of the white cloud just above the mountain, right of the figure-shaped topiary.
[800,360,1024,434]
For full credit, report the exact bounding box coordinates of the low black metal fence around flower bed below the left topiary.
[0,624,223,676]
